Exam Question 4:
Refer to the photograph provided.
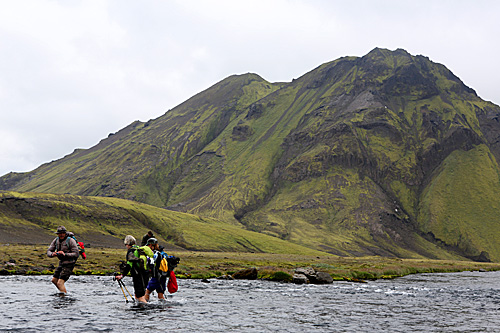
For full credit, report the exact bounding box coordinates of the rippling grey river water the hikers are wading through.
[0,272,500,332]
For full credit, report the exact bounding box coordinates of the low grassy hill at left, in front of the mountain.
[0,192,321,255]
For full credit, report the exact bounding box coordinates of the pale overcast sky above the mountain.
[0,0,500,176]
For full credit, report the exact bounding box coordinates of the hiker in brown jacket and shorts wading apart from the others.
[47,226,80,294]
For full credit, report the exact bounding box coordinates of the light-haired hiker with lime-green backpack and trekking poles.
[116,235,153,303]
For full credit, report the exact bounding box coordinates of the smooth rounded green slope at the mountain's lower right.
[419,145,500,261]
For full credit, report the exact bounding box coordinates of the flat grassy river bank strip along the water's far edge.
[0,244,500,281]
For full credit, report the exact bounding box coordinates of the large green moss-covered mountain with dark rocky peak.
[0,49,500,261]
